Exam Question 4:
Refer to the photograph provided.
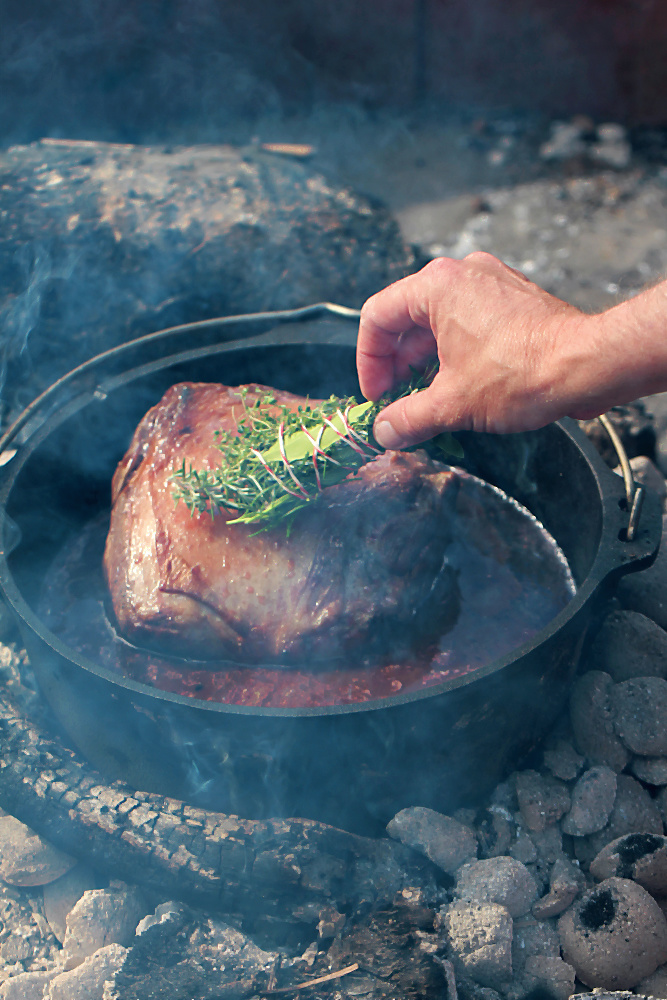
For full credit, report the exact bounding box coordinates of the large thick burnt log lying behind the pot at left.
[0,139,415,409]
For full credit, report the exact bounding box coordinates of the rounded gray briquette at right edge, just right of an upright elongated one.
[610,677,667,757]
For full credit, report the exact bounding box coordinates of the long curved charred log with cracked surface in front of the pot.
[0,647,437,930]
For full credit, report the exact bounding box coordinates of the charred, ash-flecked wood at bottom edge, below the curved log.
[104,897,456,1000]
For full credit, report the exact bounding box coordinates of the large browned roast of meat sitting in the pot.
[104,383,458,664]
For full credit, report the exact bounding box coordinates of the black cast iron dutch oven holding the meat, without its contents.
[0,306,661,832]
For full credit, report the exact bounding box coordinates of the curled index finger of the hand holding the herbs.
[357,275,430,399]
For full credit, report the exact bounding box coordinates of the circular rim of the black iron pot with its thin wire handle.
[0,303,660,718]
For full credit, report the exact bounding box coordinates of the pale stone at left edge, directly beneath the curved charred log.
[0,816,76,887]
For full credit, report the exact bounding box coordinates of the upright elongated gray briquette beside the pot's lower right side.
[570,670,630,773]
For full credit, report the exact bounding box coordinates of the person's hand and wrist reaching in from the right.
[357,252,667,448]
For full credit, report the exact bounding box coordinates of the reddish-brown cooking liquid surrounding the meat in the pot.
[41,470,575,708]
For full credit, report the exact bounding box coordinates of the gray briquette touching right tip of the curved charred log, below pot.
[387,806,477,874]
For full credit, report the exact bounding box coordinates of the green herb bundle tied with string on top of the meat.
[170,376,462,528]
